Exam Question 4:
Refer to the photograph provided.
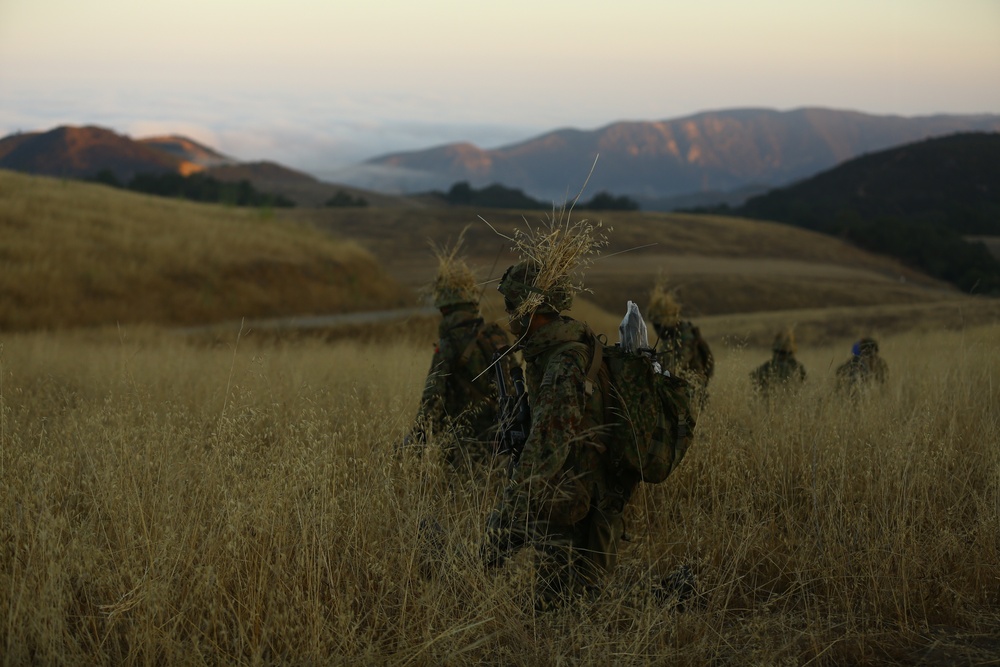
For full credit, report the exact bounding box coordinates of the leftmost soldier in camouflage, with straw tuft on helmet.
[405,241,516,467]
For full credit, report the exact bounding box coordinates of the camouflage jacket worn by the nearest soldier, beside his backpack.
[506,317,615,525]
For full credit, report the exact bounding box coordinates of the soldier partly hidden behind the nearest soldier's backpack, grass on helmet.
[646,282,715,403]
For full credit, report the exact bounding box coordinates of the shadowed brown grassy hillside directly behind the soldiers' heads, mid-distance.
[290,208,958,316]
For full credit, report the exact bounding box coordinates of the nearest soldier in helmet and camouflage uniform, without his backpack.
[483,262,637,607]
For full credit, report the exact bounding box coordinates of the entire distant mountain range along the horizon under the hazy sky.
[7,107,1000,211]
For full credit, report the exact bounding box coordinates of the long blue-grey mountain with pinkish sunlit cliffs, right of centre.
[360,108,1000,208]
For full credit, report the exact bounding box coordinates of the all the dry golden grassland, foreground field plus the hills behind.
[0,172,1000,666]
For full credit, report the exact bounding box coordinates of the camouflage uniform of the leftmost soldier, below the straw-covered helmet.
[410,303,513,466]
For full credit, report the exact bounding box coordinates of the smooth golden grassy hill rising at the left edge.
[0,171,412,330]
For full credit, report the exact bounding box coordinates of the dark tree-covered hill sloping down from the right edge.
[728,133,1000,294]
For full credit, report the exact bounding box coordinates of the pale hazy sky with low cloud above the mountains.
[0,0,1000,172]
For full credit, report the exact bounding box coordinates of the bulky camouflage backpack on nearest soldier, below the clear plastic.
[587,337,695,484]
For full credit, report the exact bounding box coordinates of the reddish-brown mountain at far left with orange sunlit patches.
[0,126,201,181]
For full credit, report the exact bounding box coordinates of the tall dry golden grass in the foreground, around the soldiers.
[0,327,1000,665]
